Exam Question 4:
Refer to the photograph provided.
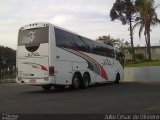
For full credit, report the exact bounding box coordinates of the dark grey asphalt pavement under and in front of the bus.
[0,83,160,114]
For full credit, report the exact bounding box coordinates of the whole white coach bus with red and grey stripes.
[16,23,124,90]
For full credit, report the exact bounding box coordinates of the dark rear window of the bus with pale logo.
[18,27,49,46]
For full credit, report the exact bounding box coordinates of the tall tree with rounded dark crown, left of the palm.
[110,0,136,61]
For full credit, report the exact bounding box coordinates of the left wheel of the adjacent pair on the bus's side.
[71,74,80,89]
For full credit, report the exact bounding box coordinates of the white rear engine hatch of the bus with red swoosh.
[18,57,49,78]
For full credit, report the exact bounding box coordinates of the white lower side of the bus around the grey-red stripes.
[55,47,116,85]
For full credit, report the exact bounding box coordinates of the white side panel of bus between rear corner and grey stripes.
[55,47,87,85]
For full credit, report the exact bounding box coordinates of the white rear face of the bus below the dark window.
[17,43,49,84]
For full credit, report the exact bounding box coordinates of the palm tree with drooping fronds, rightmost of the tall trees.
[133,0,160,61]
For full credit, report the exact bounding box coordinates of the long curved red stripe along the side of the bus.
[77,51,108,80]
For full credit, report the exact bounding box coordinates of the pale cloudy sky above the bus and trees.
[0,0,160,50]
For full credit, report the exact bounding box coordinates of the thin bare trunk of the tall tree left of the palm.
[129,17,136,62]
